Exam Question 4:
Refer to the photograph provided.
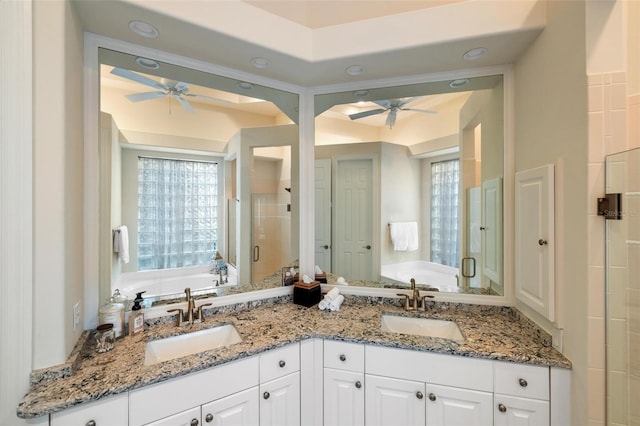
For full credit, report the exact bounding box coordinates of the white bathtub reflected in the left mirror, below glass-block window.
[111,265,237,307]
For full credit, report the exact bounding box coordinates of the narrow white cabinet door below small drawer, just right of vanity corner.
[324,368,365,426]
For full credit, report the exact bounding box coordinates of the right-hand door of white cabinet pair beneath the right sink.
[427,384,493,426]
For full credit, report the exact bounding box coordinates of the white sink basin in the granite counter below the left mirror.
[144,324,242,365]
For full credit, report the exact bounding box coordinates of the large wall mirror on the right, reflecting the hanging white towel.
[315,75,505,295]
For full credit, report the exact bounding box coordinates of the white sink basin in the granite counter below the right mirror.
[381,315,464,342]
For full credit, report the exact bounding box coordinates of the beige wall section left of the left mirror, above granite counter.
[33,1,84,368]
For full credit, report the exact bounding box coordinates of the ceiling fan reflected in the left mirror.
[111,67,231,113]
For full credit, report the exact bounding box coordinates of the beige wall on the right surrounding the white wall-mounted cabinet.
[515,1,591,425]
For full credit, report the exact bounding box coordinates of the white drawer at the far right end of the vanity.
[493,361,549,401]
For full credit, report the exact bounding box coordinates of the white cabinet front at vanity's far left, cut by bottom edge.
[50,393,129,426]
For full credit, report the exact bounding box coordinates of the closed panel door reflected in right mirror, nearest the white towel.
[333,159,375,280]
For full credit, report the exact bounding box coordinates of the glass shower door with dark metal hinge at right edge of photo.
[599,149,640,425]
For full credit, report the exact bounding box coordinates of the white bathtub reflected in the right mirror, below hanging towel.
[380,260,459,292]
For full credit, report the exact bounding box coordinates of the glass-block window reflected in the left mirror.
[138,157,218,271]
